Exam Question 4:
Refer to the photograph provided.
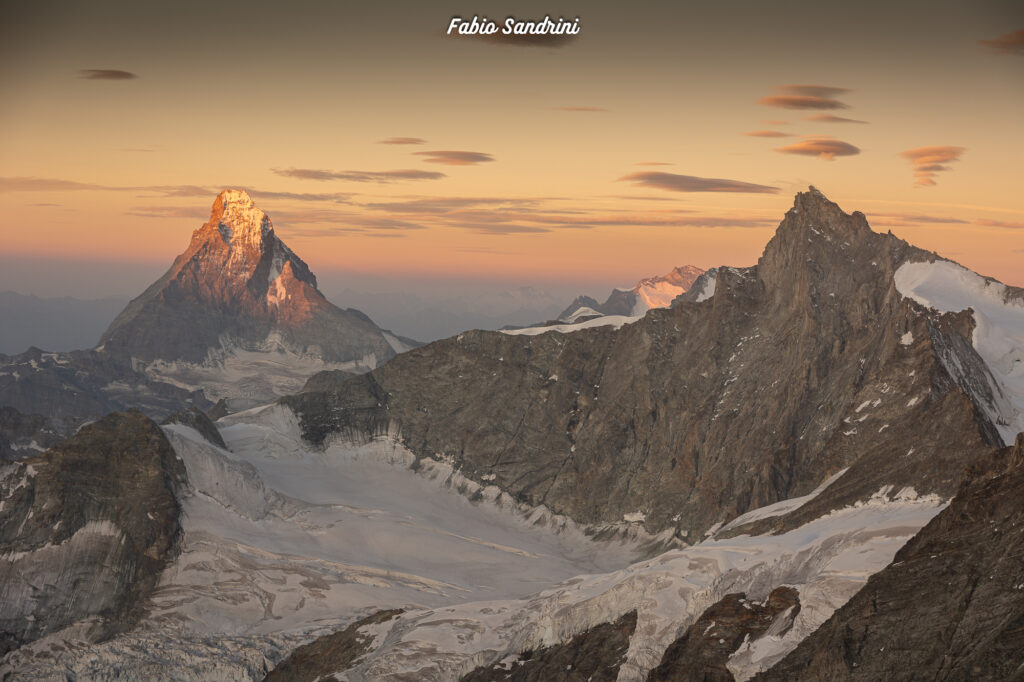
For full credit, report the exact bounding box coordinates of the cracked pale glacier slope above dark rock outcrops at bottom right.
[299,491,943,681]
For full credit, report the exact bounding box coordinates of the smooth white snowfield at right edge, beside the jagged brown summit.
[895,260,1024,445]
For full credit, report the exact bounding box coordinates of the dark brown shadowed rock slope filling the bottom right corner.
[755,434,1024,682]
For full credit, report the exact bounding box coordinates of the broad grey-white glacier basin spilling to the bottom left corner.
[0,406,640,680]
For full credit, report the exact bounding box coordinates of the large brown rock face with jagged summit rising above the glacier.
[285,188,1000,542]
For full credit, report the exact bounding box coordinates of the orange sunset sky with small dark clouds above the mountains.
[0,0,1024,297]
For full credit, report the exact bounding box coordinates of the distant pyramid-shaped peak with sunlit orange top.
[100,189,394,366]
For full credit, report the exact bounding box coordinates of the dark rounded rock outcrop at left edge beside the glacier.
[0,412,184,653]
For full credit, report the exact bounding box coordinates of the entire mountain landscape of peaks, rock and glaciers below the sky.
[0,187,1024,682]
